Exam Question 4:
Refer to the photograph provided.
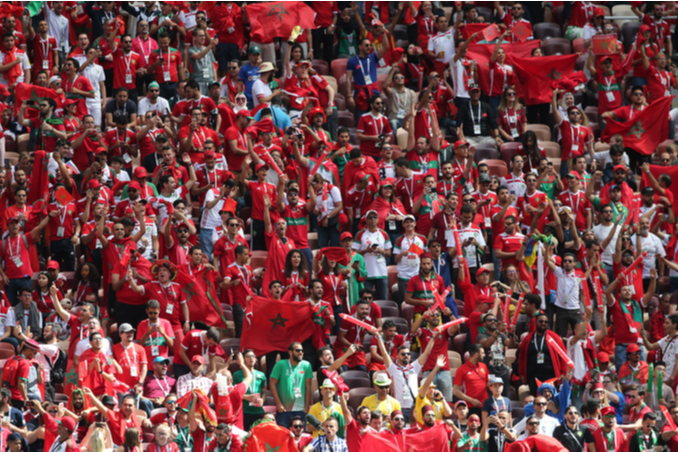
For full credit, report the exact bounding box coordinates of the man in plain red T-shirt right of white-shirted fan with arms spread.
[454,344,490,416]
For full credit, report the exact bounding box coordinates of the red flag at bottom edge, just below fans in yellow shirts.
[360,424,450,452]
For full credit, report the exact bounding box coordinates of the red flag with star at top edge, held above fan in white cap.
[245,2,318,42]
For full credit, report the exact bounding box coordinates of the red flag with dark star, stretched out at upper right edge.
[600,96,673,155]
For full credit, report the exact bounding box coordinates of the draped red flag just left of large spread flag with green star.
[176,265,227,330]
